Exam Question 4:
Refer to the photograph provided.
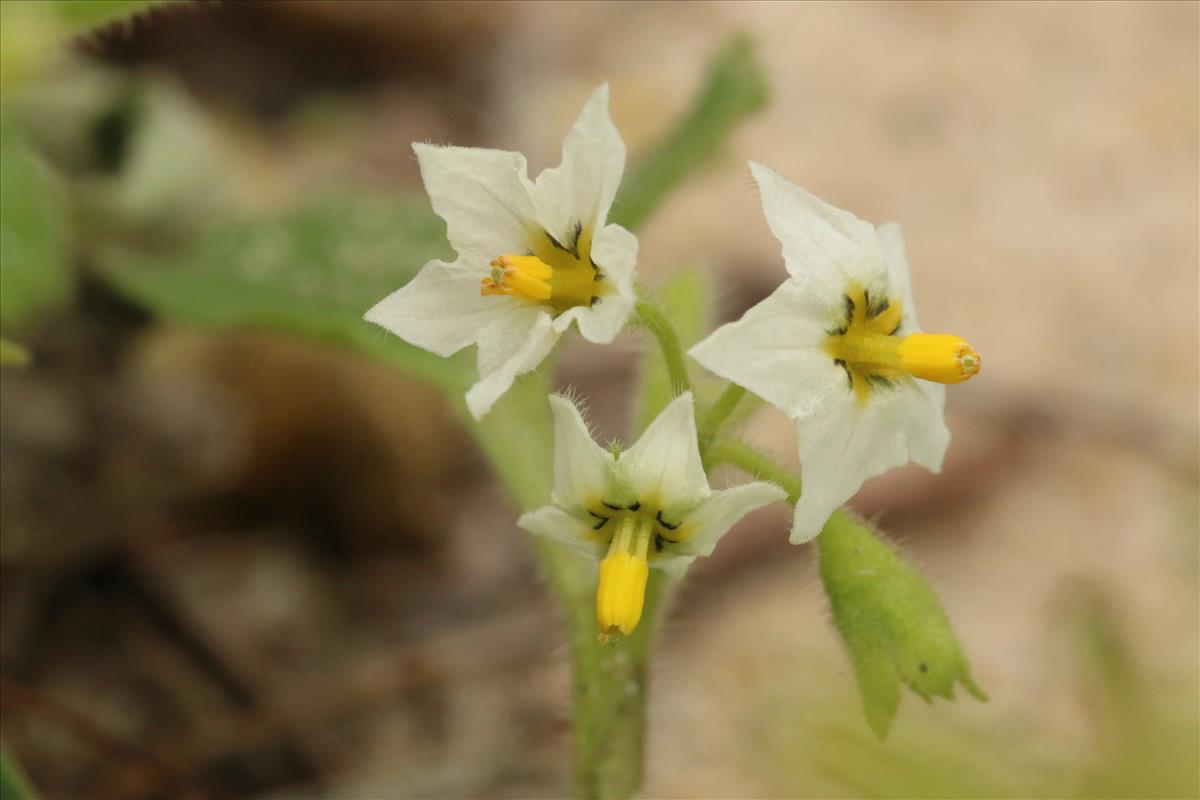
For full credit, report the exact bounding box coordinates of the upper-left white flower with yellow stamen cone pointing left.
[366,85,637,419]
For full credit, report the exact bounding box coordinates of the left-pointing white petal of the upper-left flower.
[364,261,518,356]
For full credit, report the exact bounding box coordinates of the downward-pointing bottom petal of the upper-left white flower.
[467,306,558,420]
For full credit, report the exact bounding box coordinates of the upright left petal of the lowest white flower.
[550,395,613,516]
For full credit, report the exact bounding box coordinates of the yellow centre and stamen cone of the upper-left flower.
[479,222,607,313]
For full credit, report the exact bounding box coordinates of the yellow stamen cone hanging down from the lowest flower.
[596,516,652,642]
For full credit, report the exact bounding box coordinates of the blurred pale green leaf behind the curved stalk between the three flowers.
[635,267,713,431]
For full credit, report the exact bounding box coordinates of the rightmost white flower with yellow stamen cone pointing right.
[690,162,979,543]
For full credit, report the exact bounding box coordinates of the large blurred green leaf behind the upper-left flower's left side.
[102,196,474,392]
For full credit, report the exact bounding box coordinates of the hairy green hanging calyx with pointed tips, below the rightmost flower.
[817,511,988,739]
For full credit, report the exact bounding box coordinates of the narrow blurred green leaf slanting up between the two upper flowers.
[610,34,768,230]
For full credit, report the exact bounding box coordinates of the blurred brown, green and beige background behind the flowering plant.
[0,1,1200,800]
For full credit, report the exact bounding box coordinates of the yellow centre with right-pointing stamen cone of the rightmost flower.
[826,285,982,404]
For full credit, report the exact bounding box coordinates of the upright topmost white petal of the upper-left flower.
[536,84,625,241]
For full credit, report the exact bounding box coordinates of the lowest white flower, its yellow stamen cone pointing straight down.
[517,392,787,637]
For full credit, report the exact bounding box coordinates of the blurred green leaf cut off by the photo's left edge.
[0,116,73,331]
